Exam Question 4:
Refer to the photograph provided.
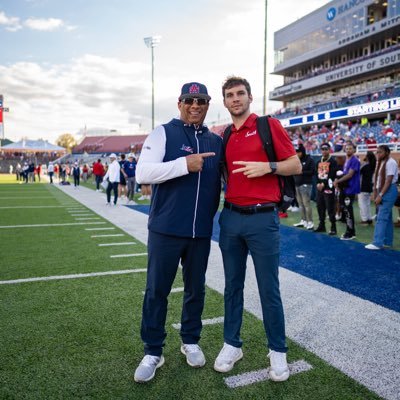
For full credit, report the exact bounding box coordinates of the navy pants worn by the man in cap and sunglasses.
[141,231,210,356]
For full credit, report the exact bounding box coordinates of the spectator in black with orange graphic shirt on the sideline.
[314,143,338,235]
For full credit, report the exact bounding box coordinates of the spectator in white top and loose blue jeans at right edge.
[365,145,399,250]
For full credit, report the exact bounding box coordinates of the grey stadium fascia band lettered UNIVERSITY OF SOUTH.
[269,50,400,100]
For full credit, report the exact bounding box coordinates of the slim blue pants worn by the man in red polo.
[219,208,287,353]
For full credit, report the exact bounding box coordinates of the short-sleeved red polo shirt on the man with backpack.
[225,114,296,206]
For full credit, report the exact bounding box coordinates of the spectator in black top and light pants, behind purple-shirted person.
[358,151,376,225]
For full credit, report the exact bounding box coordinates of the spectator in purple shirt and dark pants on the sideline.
[333,142,360,240]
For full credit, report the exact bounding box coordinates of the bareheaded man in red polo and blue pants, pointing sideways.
[214,77,301,381]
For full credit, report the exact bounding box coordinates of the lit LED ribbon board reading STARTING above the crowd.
[280,97,400,128]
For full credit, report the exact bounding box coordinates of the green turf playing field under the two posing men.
[0,175,379,400]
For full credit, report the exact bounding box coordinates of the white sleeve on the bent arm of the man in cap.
[136,125,189,184]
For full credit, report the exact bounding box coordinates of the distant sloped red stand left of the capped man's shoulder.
[72,135,147,153]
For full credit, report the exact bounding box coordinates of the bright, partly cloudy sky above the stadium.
[0,0,328,142]
